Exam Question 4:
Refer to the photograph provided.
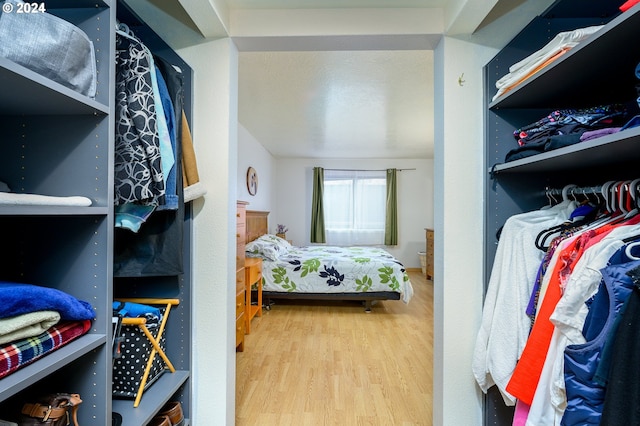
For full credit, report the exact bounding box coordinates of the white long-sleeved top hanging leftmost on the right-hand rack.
[472,201,577,405]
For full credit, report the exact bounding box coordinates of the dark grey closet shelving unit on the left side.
[0,0,191,426]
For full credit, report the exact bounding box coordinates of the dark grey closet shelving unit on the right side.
[484,0,640,425]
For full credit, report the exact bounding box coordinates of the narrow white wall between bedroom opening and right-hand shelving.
[433,37,496,426]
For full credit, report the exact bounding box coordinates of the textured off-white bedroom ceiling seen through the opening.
[239,50,433,158]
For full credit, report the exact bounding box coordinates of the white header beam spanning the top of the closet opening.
[230,8,444,51]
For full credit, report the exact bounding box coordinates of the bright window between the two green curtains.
[324,170,387,246]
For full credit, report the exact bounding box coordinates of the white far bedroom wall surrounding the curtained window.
[269,159,433,268]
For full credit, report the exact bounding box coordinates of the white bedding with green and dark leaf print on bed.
[262,246,413,303]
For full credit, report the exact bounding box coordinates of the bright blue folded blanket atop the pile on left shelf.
[0,281,96,320]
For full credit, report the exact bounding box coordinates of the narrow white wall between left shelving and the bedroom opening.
[178,39,238,426]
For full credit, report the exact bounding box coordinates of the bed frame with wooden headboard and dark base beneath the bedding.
[246,210,400,313]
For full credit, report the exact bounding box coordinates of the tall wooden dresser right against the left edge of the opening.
[235,201,248,352]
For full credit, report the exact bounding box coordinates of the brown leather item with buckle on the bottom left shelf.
[18,393,82,426]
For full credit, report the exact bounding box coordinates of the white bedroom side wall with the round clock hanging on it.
[238,124,275,214]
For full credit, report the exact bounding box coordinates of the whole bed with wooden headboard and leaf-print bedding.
[246,210,413,312]
